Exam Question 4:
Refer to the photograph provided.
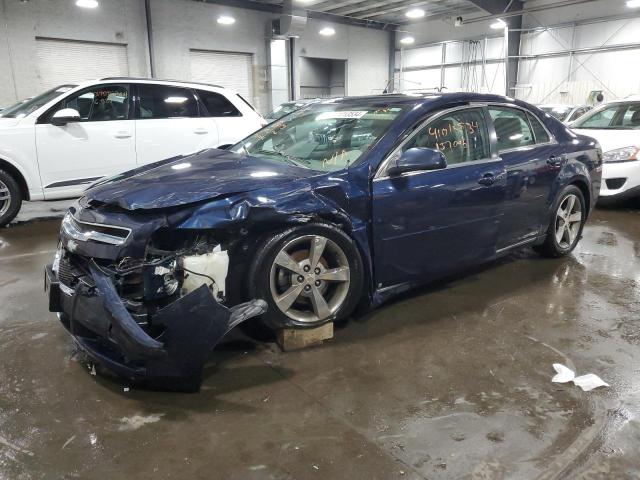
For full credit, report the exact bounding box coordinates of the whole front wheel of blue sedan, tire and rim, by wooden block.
[249,224,364,329]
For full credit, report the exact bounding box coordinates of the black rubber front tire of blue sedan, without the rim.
[248,223,364,334]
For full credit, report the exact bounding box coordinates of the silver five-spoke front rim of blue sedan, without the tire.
[269,235,351,324]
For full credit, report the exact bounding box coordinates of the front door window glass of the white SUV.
[41,84,131,123]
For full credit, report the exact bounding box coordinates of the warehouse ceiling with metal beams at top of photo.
[248,0,481,25]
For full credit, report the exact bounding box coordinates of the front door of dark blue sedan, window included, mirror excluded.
[373,107,506,288]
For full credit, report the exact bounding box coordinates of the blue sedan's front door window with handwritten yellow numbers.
[402,108,491,165]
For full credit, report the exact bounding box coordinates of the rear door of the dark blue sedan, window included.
[489,105,566,250]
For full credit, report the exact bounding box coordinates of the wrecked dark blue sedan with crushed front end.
[46,94,602,389]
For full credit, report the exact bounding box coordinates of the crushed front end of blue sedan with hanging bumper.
[45,204,266,391]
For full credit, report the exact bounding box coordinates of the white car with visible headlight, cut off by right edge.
[571,100,640,203]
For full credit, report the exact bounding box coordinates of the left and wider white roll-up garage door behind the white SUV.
[36,38,129,89]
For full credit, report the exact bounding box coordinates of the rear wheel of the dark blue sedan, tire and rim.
[536,185,587,258]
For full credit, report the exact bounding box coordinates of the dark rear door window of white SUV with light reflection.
[138,84,198,119]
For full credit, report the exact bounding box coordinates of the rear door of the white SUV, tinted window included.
[136,83,218,165]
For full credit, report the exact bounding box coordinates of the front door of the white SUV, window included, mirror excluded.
[35,84,136,200]
